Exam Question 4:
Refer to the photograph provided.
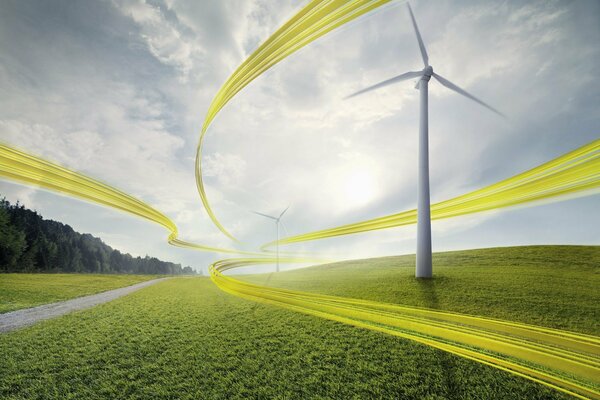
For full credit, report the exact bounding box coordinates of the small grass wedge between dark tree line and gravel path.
[0,274,155,313]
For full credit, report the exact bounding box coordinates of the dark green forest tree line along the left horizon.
[0,198,195,274]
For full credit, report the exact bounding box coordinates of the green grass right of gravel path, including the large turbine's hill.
[0,246,600,399]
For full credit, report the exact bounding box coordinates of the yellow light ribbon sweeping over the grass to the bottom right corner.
[209,258,600,399]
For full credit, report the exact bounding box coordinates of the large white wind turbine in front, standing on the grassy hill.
[347,3,505,278]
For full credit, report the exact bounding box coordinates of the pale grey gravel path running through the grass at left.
[0,278,169,333]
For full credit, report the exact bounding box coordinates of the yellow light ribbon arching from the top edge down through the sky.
[196,0,390,240]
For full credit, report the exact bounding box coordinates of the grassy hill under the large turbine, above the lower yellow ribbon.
[243,246,600,335]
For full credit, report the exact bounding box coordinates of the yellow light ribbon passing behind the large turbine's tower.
[261,139,600,250]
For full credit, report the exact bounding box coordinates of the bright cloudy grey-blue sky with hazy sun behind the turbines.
[0,0,600,270]
